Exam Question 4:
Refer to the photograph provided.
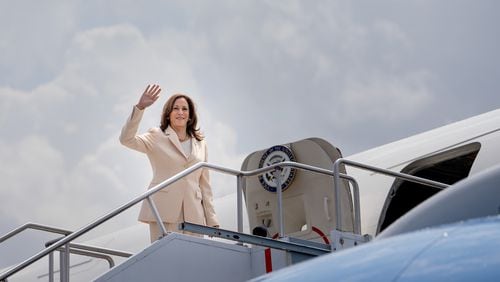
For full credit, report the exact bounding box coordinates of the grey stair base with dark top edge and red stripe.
[96,223,330,282]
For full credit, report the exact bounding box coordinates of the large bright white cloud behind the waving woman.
[0,18,242,238]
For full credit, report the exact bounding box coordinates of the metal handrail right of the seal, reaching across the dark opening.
[333,158,449,231]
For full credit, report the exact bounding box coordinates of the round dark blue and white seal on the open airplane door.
[259,145,296,192]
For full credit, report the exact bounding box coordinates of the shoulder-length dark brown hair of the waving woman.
[160,94,204,141]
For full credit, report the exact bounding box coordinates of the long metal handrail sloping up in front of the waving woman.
[0,162,356,281]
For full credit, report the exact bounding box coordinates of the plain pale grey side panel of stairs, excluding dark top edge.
[95,233,285,282]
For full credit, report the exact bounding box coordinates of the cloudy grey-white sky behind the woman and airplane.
[0,0,500,268]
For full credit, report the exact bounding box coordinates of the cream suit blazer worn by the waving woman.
[120,106,219,226]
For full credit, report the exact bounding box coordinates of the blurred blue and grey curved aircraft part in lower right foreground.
[251,165,500,281]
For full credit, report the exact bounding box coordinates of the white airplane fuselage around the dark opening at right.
[346,110,500,235]
